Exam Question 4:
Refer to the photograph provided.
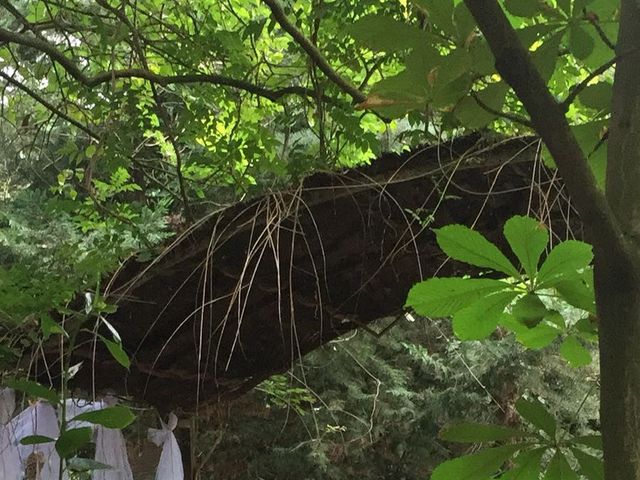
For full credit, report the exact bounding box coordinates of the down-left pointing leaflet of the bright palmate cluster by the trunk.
[453,291,518,340]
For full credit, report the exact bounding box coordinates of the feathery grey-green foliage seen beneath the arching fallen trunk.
[202,319,598,480]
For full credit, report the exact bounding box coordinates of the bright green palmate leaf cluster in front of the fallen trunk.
[407,216,596,366]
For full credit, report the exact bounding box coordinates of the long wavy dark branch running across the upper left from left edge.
[0,28,336,103]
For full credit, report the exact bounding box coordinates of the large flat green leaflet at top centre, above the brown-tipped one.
[346,15,431,53]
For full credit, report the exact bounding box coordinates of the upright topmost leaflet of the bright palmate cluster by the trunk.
[503,216,549,278]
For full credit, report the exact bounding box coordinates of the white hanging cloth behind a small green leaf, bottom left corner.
[7,400,67,480]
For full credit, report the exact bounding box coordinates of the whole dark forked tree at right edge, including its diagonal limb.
[465,0,640,480]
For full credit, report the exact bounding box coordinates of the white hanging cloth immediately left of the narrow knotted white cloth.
[91,397,133,480]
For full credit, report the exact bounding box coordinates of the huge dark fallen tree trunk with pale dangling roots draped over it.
[66,134,570,410]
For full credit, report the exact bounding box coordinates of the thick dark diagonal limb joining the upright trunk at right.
[464,0,628,251]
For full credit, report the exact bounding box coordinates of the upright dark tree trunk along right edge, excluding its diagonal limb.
[594,0,640,480]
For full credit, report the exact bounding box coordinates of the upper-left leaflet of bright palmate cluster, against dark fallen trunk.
[435,225,520,278]
